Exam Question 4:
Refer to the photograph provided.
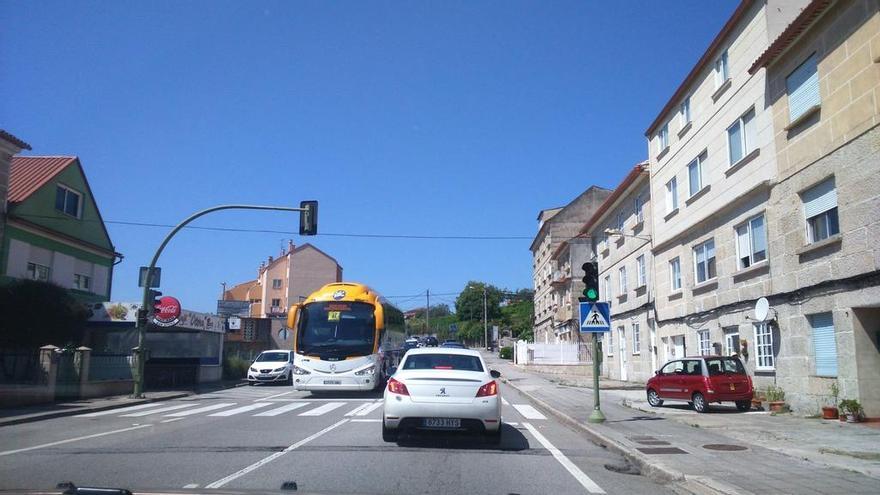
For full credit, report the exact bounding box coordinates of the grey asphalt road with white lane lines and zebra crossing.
[0,386,670,495]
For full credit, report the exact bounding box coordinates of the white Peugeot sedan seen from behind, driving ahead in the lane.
[382,347,501,443]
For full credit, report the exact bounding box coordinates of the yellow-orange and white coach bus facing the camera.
[287,282,405,391]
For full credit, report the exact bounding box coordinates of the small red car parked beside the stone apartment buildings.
[645,356,755,413]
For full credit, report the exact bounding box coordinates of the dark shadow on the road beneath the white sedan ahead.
[397,423,529,452]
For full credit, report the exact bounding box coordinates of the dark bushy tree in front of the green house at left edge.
[0,280,90,349]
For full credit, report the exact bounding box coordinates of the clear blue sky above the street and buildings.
[0,0,738,311]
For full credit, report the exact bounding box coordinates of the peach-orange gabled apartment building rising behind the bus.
[224,241,342,318]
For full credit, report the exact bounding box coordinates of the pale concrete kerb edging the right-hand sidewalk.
[501,378,742,495]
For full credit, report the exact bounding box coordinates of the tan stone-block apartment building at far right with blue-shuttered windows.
[750,0,880,417]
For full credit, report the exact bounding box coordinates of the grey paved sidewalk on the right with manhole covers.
[484,353,880,495]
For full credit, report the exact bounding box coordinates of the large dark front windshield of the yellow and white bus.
[296,301,376,359]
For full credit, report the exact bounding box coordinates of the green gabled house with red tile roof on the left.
[0,156,122,302]
